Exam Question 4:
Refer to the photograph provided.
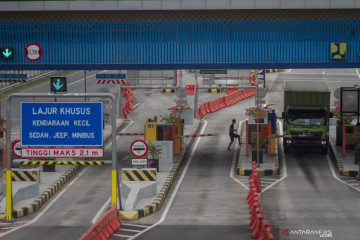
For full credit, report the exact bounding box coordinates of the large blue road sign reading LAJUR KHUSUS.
[20,102,103,146]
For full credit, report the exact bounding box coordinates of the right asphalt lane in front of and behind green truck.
[262,69,360,240]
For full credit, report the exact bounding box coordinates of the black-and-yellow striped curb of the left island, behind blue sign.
[0,121,125,221]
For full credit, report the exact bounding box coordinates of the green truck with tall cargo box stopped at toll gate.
[282,81,332,155]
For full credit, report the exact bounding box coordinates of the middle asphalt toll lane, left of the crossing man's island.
[131,95,253,240]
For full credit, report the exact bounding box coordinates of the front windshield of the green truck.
[287,109,326,126]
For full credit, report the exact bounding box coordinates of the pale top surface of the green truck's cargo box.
[284,81,330,92]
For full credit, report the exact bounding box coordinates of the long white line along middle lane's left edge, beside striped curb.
[128,119,207,240]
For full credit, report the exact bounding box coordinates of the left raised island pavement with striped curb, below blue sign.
[0,119,124,221]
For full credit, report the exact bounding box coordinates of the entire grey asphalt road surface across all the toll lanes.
[2,69,360,240]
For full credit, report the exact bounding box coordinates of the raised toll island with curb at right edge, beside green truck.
[329,126,360,177]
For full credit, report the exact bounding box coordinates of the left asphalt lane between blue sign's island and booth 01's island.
[0,72,232,240]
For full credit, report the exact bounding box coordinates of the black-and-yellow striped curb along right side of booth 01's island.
[118,121,202,221]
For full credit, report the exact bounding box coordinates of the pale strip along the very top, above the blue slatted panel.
[0,0,360,11]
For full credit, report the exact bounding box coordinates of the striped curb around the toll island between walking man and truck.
[237,122,280,176]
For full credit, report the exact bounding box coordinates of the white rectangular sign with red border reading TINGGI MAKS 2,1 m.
[21,148,104,158]
